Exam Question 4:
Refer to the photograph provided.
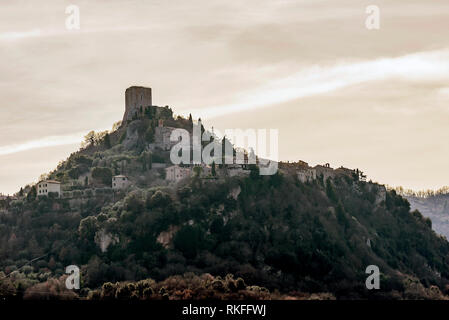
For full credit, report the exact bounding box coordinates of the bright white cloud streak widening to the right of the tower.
[193,49,449,118]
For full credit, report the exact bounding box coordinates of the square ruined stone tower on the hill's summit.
[123,86,152,123]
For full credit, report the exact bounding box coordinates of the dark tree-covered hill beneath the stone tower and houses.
[0,85,449,299]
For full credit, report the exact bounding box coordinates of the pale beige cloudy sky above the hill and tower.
[0,0,449,194]
